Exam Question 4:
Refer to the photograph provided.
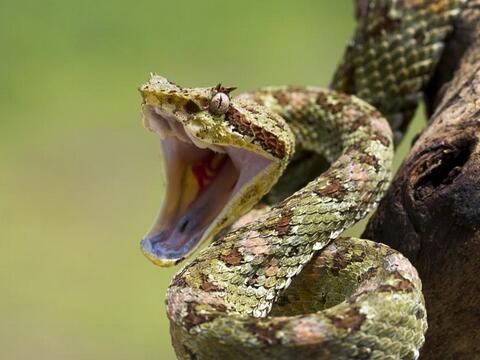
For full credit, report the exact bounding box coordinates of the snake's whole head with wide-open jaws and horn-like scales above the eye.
[135,74,294,266]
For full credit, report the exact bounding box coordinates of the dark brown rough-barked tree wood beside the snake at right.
[359,0,480,359]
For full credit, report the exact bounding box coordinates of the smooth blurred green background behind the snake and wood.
[0,0,422,360]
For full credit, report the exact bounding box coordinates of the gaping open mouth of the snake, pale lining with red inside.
[142,105,272,266]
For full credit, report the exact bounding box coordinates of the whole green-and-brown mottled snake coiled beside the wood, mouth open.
[140,0,465,359]
